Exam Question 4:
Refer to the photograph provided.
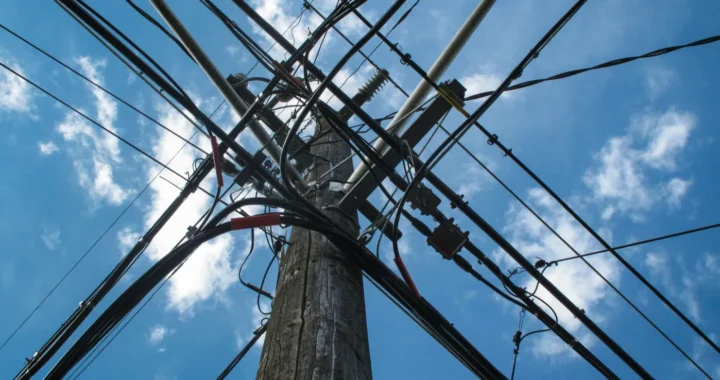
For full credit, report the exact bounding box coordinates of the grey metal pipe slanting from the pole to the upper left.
[150,0,306,190]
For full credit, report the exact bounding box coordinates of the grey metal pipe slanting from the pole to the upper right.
[345,0,495,191]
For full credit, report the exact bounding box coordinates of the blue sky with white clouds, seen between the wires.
[0,0,720,379]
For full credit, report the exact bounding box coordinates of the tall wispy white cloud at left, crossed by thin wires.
[55,57,134,205]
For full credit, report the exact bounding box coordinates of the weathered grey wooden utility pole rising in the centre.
[257,73,384,380]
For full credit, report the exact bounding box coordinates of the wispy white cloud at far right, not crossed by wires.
[583,109,695,220]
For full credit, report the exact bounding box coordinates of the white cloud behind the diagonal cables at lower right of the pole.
[495,188,620,356]
